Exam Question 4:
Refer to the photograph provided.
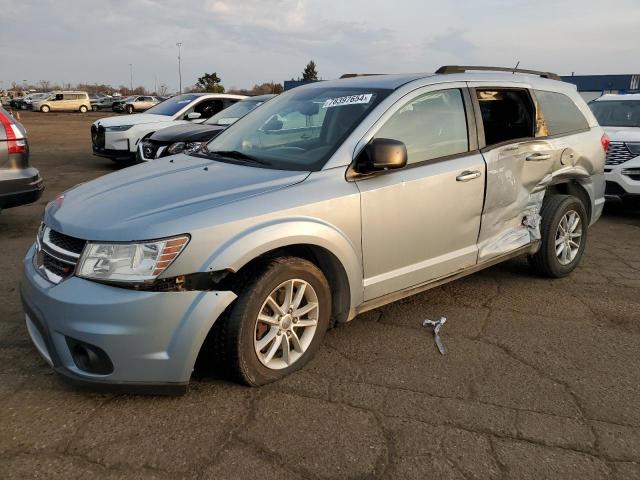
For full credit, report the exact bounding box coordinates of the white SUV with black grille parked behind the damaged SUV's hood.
[91,93,246,162]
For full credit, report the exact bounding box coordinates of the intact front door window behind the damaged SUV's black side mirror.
[376,89,469,163]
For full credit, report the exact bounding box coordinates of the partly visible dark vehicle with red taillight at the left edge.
[0,107,44,210]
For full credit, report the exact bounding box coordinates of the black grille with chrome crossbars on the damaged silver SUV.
[36,225,87,283]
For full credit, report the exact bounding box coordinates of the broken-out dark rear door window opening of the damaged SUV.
[476,88,535,146]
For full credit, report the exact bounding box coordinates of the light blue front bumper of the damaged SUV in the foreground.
[21,246,236,393]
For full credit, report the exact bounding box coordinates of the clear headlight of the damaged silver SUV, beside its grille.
[76,235,189,283]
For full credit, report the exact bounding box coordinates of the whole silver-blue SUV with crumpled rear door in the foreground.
[21,66,608,391]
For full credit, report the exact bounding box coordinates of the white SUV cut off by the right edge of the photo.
[589,93,640,199]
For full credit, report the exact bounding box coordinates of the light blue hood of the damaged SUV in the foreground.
[45,155,309,241]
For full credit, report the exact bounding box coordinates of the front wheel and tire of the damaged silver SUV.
[212,257,331,386]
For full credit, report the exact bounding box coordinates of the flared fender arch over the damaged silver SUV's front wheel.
[202,217,363,307]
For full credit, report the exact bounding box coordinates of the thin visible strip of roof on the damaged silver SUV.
[298,71,576,91]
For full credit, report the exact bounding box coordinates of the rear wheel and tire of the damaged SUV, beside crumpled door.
[529,195,588,278]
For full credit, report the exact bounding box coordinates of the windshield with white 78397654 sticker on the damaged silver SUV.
[200,86,390,171]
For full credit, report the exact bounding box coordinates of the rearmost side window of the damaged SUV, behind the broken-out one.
[535,90,589,136]
